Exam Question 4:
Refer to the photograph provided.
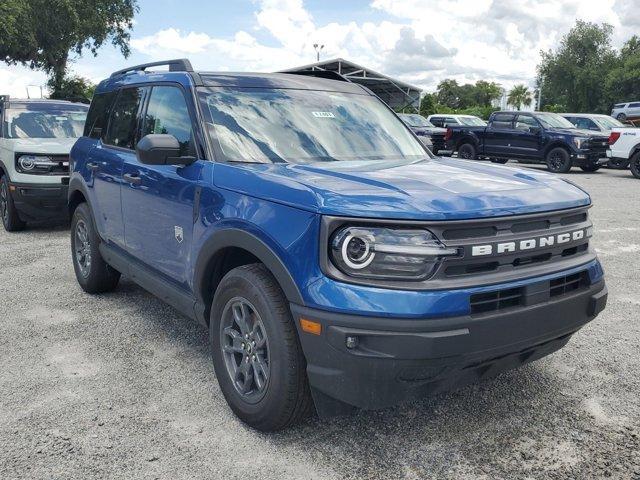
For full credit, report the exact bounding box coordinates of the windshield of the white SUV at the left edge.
[4,104,88,138]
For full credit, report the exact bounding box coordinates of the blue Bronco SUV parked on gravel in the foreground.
[69,60,607,431]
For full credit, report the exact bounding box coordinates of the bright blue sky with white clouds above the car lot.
[0,0,640,97]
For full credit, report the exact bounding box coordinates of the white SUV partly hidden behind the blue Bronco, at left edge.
[0,96,88,232]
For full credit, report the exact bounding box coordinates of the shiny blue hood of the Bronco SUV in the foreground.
[214,158,590,220]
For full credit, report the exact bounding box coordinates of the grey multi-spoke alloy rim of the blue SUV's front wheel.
[220,297,271,403]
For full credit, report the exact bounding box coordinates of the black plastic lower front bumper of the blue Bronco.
[291,280,607,416]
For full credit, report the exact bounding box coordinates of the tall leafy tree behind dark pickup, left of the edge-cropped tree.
[537,20,616,112]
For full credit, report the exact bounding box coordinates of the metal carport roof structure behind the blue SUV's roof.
[281,58,422,112]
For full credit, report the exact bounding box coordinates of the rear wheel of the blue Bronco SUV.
[71,203,120,293]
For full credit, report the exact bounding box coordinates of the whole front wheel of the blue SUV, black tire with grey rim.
[209,263,313,432]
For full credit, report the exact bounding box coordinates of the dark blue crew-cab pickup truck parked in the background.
[445,112,608,173]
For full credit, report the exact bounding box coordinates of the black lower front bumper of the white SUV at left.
[9,181,69,221]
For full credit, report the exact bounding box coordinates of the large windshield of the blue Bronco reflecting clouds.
[200,88,428,163]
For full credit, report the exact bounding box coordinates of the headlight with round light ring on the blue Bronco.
[330,227,460,281]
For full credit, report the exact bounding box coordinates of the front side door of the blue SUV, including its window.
[122,84,203,288]
